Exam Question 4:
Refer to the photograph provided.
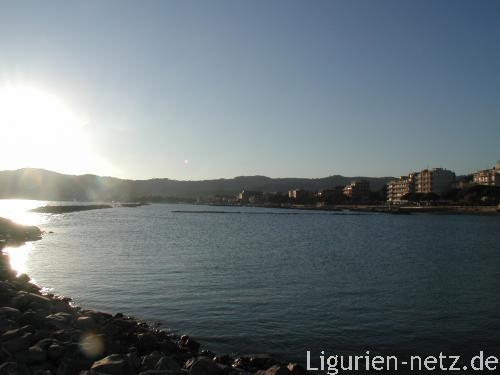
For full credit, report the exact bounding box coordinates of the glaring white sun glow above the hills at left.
[0,86,110,173]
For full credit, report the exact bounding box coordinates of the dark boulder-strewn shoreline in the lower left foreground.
[0,219,307,375]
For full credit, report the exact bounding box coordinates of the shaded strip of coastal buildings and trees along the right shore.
[210,161,500,208]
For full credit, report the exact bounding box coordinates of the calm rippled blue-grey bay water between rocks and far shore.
[0,201,500,362]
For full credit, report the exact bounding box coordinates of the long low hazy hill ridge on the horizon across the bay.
[0,168,392,202]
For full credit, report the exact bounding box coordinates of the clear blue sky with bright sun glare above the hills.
[0,0,500,180]
